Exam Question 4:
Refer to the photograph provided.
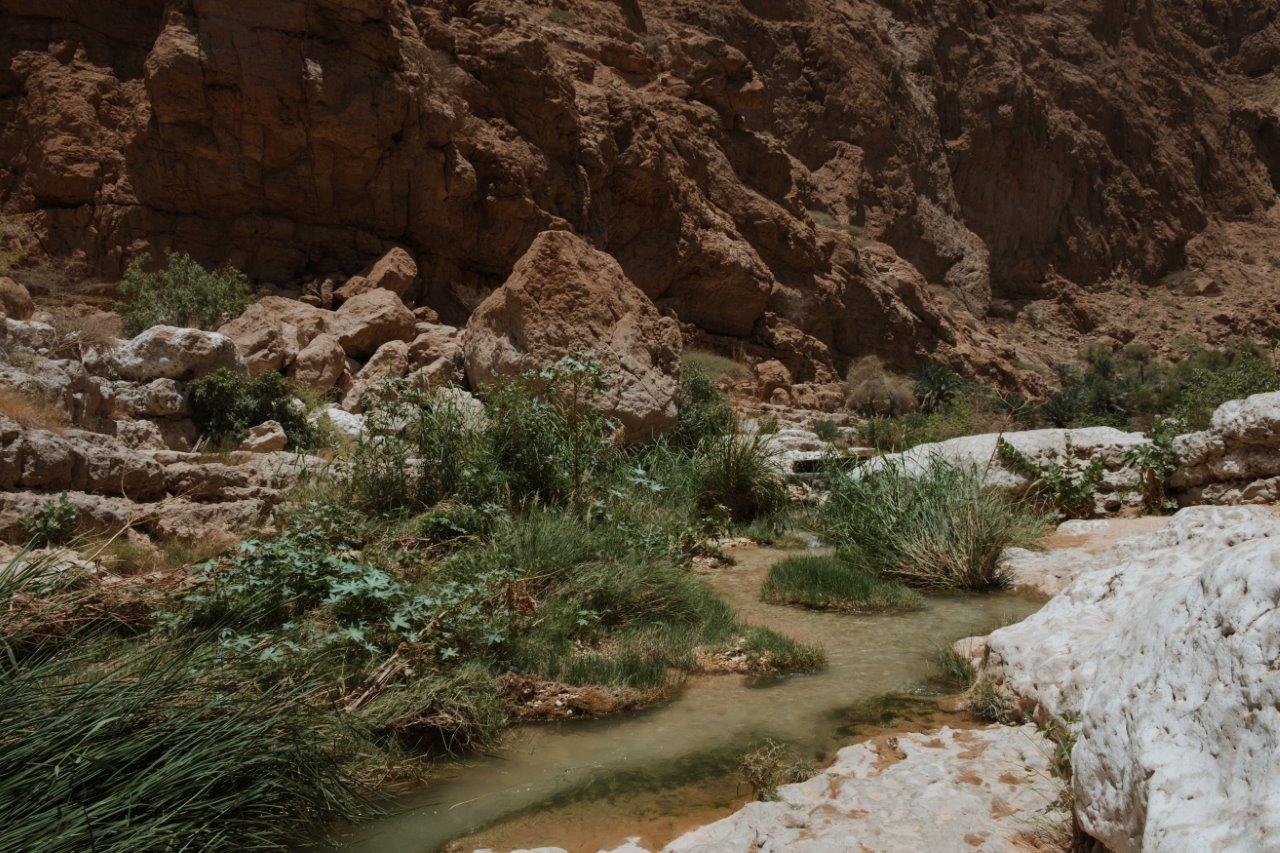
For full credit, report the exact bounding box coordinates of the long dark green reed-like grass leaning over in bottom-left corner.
[0,548,369,853]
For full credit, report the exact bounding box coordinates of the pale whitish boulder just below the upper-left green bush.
[84,325,246,382]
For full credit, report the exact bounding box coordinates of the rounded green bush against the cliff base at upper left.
[115,252,251,337]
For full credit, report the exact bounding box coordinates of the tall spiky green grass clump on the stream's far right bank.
[818,457,1047,590]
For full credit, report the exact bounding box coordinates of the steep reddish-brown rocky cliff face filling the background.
[0,0,1280,386]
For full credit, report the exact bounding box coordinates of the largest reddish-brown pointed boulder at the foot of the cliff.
[460,231,681,441]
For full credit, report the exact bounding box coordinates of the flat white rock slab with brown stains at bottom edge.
[666,725,1068,853]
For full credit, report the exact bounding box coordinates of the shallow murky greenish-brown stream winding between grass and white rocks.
[344,546,1038,853]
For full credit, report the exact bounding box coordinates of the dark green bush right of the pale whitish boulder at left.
[188,368,315,447]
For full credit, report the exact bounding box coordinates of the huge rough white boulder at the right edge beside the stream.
[967,506,1280,853]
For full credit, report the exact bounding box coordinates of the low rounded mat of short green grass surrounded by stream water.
[760,556,924,612]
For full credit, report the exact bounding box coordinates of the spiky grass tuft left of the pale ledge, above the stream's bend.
[695,433,787,521]
